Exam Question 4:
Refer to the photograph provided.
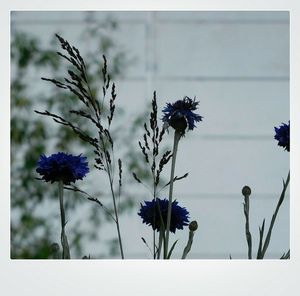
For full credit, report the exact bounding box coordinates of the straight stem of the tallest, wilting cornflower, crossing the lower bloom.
[164,131,181,259]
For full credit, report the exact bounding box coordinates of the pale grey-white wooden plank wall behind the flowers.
[12,11,289,258]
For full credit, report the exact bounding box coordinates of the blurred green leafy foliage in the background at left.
[11,16,155,259]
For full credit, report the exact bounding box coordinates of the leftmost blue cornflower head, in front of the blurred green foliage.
[36,152,89,184]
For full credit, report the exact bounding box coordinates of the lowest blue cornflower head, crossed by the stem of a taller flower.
[138,198,189,233]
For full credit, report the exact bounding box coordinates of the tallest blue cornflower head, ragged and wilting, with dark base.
[162,96,203,134]
